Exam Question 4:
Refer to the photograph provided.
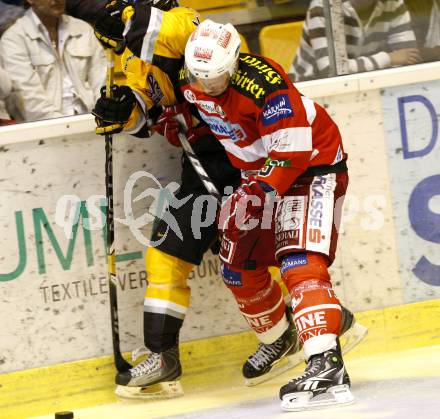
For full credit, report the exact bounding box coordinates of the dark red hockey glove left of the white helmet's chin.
[154,102,211,147]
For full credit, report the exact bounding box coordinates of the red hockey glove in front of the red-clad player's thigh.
[218,179,266,242]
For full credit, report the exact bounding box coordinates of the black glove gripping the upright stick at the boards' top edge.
[92,85,136,135]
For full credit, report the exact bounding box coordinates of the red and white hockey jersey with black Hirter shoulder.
[180,53,346,194]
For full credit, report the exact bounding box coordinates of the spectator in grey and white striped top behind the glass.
[290,0,421,81]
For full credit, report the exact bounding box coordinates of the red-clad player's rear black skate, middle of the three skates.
[243,325,300,386]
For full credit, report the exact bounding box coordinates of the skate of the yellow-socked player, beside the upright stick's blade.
[115,346,183,399]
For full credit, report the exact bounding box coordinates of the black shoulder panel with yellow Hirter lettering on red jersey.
[231,53,288,106]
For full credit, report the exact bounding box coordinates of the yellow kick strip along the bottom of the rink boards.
[0,300,440,419]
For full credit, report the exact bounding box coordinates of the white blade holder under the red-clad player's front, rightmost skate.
[281,384,354,412]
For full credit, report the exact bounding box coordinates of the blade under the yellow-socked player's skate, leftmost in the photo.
[115,381,183,400]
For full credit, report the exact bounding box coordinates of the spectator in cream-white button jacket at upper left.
[0,0,106,121]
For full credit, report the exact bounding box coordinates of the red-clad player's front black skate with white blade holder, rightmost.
[280,342,354,412]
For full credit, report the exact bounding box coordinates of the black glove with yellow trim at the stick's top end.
[95,0,133,54]
